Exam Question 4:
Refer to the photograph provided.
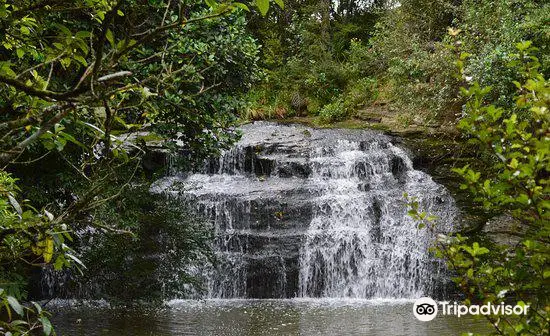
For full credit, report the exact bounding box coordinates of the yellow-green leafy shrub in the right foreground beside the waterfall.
[409,41,550,335]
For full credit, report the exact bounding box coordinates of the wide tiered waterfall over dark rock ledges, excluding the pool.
[152,122,456,298]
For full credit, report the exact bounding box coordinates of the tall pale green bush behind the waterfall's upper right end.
[370,0,461,120]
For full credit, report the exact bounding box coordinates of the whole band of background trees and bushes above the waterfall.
[249,0,550,124]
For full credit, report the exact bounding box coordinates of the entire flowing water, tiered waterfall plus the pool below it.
[53,122,489,336]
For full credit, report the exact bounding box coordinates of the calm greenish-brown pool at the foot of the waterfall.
[52,299,491,336]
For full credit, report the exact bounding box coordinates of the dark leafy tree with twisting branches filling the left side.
[0,0,282,334]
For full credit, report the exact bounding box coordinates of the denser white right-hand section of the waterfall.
[300,140,454,298]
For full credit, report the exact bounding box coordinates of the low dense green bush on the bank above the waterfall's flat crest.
[248,39,377,122]
